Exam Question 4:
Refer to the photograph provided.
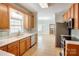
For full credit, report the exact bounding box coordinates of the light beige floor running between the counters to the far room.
[23,34,60,56]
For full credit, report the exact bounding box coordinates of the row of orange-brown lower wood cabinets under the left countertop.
[0,35,37,56]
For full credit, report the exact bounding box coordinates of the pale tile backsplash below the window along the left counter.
[0,29,36,39]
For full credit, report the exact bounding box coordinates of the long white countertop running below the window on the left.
[0,32,37,47]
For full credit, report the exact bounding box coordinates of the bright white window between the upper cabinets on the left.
[10,8,24,33]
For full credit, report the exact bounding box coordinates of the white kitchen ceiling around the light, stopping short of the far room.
[20,3,71,14]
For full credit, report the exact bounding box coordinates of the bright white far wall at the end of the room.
[38,14,55,34]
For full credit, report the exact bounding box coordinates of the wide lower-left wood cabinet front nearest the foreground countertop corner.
[8,41,19,56]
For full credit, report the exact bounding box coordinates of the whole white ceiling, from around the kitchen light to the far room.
[19,3,72,20]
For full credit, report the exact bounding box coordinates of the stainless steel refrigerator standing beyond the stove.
[55,23,68,47]
